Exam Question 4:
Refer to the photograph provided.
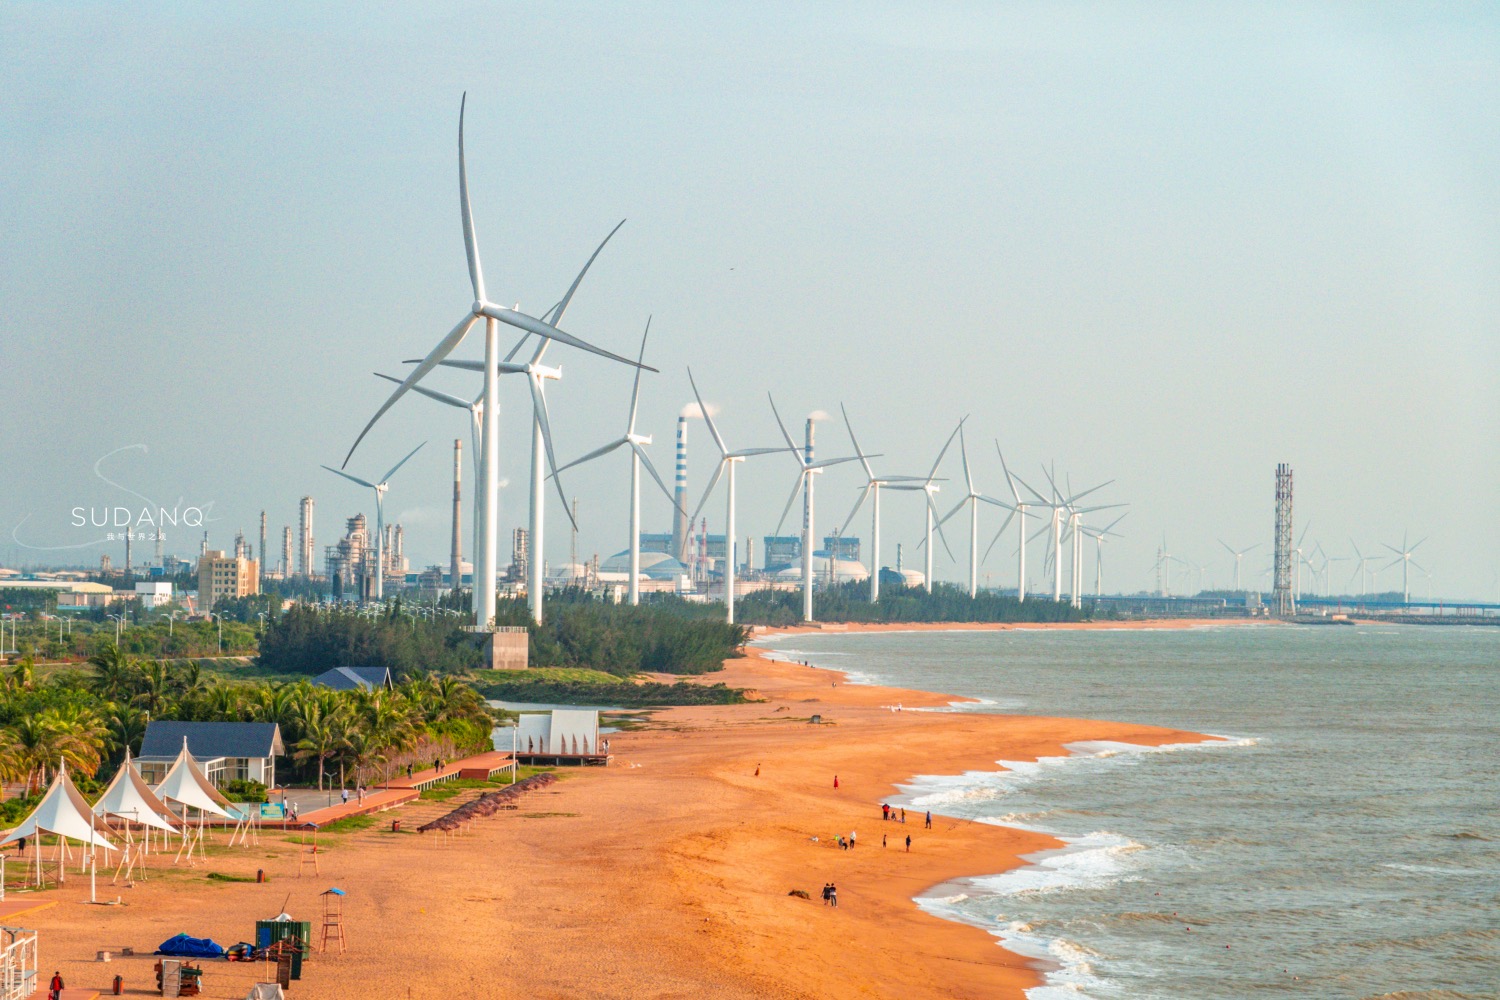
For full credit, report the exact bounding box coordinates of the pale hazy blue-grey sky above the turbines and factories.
[0,3,1500,601]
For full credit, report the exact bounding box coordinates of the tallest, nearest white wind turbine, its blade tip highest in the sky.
[344,94,656,630]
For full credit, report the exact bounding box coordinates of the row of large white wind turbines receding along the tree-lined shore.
[331,94,1121,631]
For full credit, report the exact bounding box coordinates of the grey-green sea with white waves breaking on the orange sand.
[758,624,1500,1000]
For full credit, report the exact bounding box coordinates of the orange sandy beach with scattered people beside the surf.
[6,622,1218,1000]
